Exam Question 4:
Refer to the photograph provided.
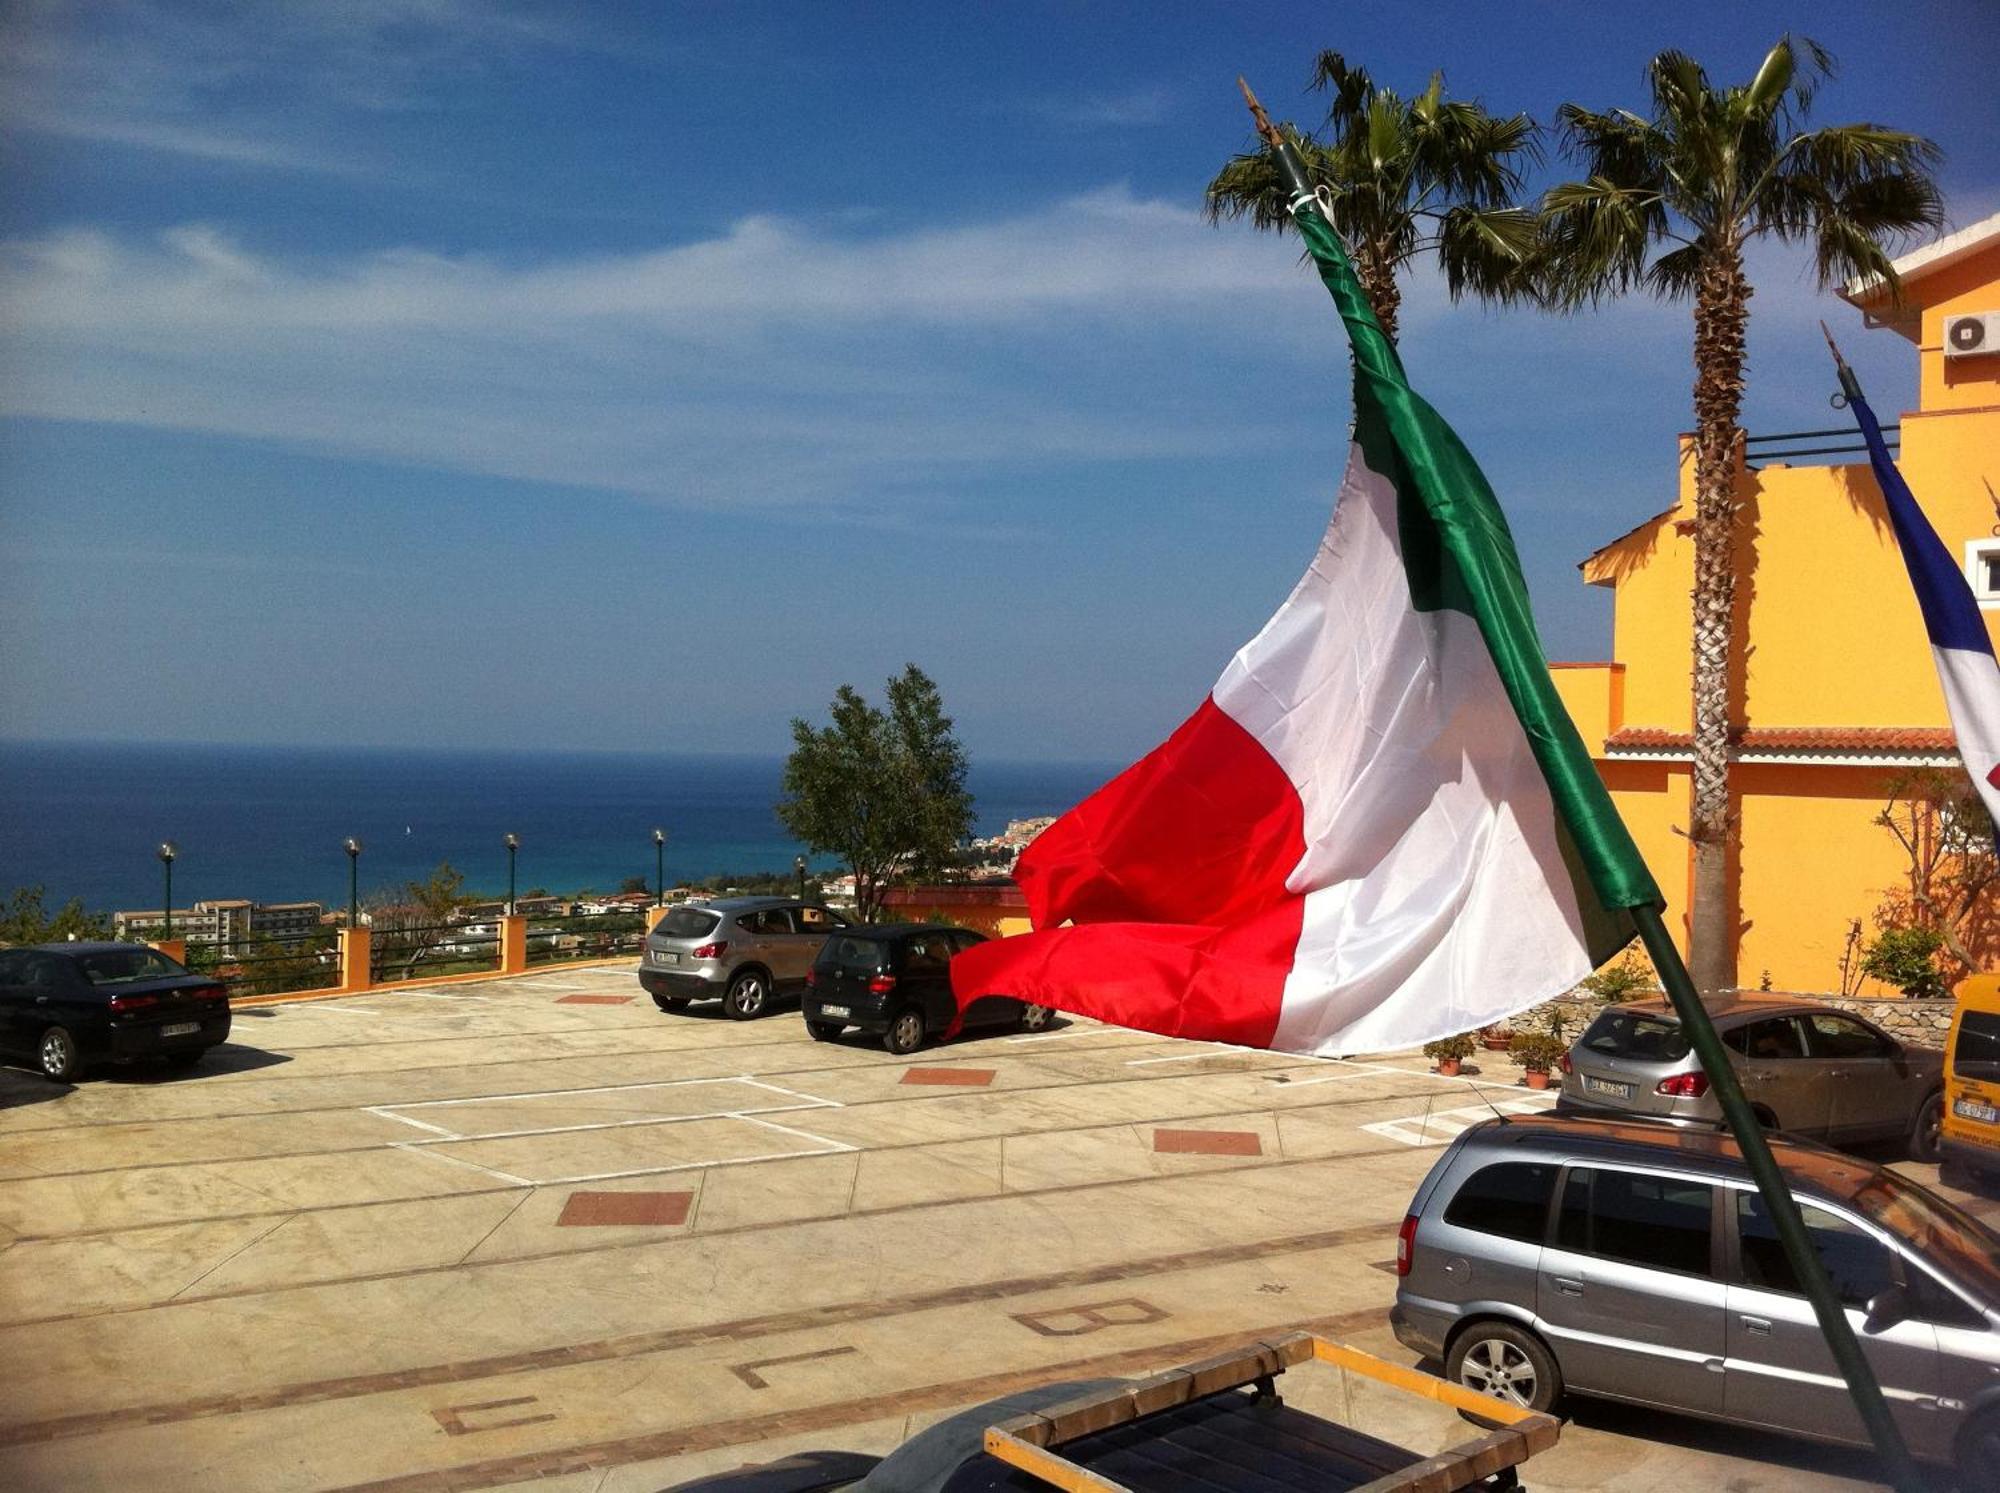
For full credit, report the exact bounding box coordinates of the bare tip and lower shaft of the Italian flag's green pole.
[1236,78,1930,1493]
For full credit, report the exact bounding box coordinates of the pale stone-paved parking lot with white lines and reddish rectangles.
[0,967,2000,1493]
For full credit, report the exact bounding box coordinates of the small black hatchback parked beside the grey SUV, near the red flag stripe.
[806,923,1050,1055]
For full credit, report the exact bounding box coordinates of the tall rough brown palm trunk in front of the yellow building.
[1688,246,1750,997]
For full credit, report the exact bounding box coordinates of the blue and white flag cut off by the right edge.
[1834,352,2000,836]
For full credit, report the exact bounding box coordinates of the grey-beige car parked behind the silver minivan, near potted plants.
[1556,995,1944,1161]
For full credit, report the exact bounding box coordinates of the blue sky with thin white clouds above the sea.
[0,0,2000,759]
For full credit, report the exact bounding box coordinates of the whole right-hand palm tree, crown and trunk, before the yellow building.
[1542,38,1944,993]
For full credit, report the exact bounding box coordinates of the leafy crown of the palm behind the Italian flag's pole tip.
[1208,52,1536,342]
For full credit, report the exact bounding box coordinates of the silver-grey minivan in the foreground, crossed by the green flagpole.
[1390,1117,2000,1493]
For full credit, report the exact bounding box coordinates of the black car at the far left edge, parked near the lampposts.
[0,943,230,1081]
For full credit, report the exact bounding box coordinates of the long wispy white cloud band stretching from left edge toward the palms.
[0,190,1330,514]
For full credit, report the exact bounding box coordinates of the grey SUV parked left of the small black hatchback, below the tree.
[638,897,848,1021]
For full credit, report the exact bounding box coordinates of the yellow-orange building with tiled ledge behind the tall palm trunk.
[1554,216,2000,995]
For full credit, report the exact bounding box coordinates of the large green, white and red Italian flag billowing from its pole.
[952,198,1660,1057]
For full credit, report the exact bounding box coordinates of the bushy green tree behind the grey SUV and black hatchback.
[778,664,972,923]
